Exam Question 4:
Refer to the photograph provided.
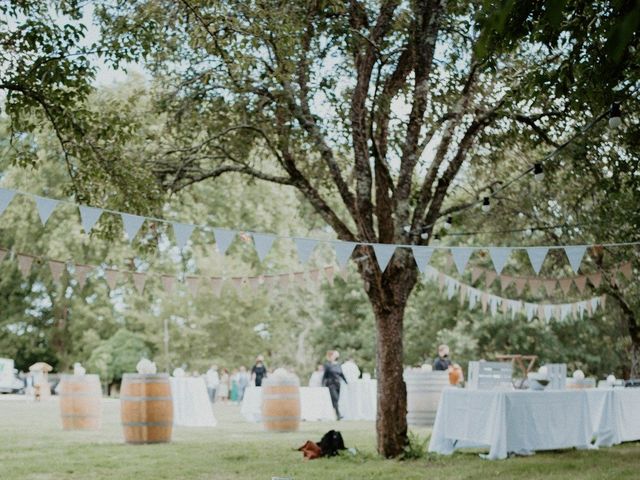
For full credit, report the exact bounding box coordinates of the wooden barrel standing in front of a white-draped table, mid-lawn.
[262,375,300,432]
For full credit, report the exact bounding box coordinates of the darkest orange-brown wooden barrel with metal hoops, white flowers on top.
[120,373,173,443]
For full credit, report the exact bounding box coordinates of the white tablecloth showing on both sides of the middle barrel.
[240,387,336,422]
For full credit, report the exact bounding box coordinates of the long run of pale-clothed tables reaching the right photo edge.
[429,388,640,459]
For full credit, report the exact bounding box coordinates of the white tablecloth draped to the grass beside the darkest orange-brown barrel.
[171,377,216,427]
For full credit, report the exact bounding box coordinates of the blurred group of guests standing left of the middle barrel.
[204,355,267,403]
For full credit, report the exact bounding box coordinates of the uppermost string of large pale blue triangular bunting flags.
[0,188,640,278]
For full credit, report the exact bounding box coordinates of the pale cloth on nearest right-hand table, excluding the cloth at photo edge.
[429,388,593,459]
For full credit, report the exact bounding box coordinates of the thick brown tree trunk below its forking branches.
[360,249,417,458]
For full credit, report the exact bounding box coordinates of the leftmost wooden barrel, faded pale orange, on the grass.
[60,375,102,430]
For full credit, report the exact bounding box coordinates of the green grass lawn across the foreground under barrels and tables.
[0,396,640,480]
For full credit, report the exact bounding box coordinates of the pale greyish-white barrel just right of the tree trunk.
[404,370,449,426]
